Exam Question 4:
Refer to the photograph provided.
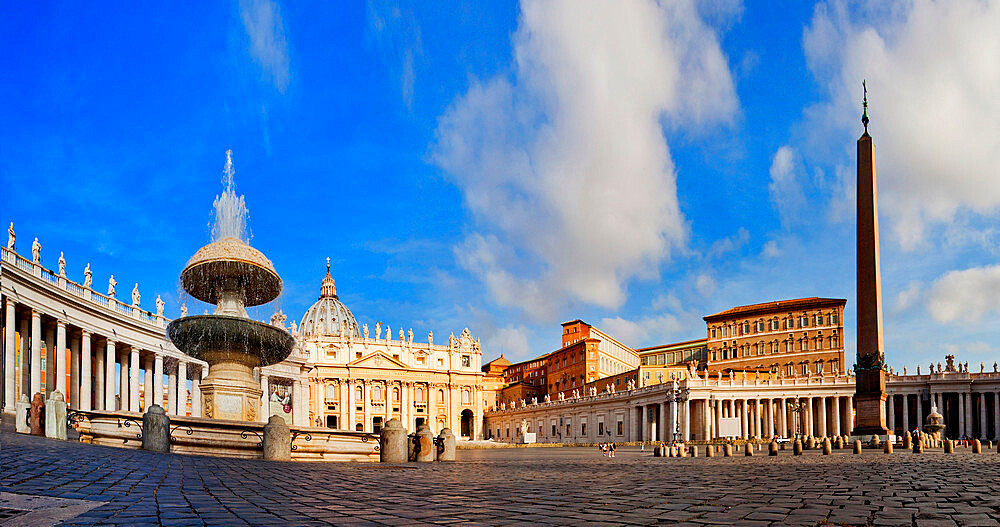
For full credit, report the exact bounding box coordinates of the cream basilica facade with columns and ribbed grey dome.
[292,263,484,439]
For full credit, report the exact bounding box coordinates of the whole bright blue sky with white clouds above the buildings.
[0,0,1000,368]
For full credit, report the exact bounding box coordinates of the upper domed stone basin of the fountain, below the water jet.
[181,238,281,306]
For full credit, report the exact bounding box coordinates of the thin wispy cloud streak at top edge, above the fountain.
[240,0,289,93]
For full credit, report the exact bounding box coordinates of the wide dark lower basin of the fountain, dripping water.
[167,315,295,366]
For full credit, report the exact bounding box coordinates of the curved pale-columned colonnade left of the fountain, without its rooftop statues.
[0,295,207,416]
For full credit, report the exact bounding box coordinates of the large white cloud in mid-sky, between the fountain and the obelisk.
[430,1,738,317]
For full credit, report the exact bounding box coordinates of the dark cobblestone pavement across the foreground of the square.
[0,431,1000,526]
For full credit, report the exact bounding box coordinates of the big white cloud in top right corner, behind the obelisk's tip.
[803,0,1000,249]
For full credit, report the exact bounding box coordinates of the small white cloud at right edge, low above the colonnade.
[927,265,1000,322]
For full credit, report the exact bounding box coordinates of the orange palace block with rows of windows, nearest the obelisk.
[704,297,847,375]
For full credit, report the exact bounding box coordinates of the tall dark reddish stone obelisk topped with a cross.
[852,83,889,436]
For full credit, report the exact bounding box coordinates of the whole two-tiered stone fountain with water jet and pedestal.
[167,150,295,421]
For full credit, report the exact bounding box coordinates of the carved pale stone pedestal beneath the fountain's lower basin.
[201,361,264,422]
